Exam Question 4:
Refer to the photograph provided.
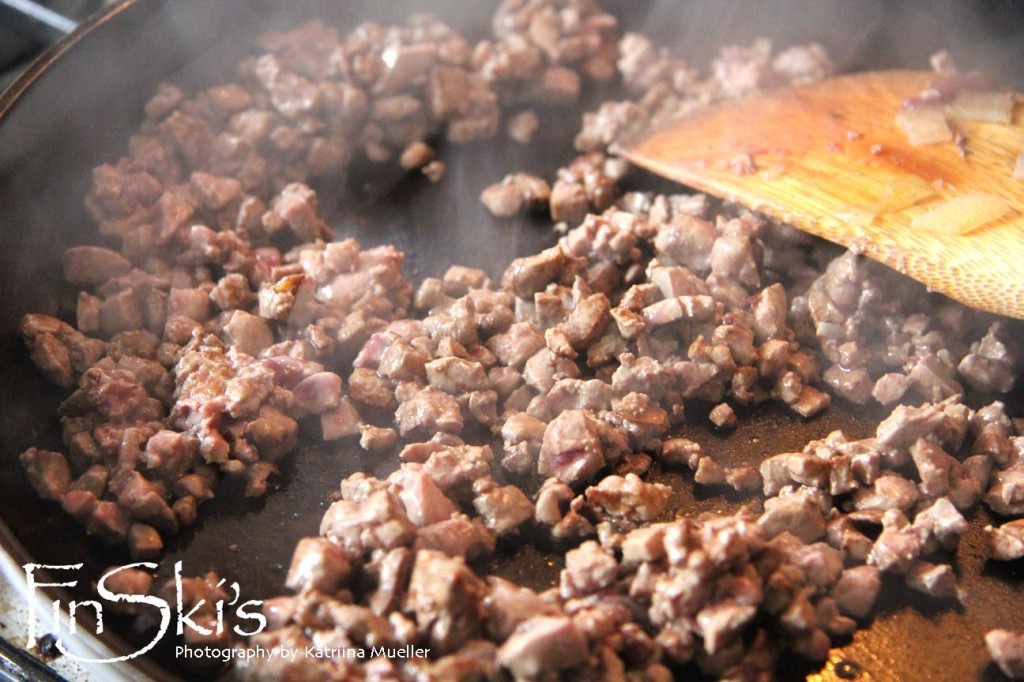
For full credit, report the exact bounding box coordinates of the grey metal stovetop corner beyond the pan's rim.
[0,0,110,90]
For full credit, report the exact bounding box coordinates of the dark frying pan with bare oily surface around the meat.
[0,0,1024,680]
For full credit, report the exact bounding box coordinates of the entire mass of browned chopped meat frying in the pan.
[14,0,1024,680]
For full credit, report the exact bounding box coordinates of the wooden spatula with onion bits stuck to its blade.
[625,71,1024,318]
